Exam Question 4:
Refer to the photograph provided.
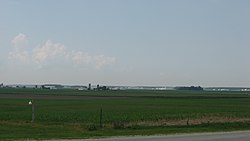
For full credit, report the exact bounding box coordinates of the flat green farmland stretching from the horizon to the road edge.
[0,88,250,140]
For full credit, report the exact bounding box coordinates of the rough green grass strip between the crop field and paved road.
[0,122,250,140]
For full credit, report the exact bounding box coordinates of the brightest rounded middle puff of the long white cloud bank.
[32,40,65,63]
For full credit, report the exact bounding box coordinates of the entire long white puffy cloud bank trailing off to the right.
[9,33,116,69]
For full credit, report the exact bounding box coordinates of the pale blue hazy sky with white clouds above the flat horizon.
[0,0,250,87]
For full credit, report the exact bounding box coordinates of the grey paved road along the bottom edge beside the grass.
[55,131,250,141]
